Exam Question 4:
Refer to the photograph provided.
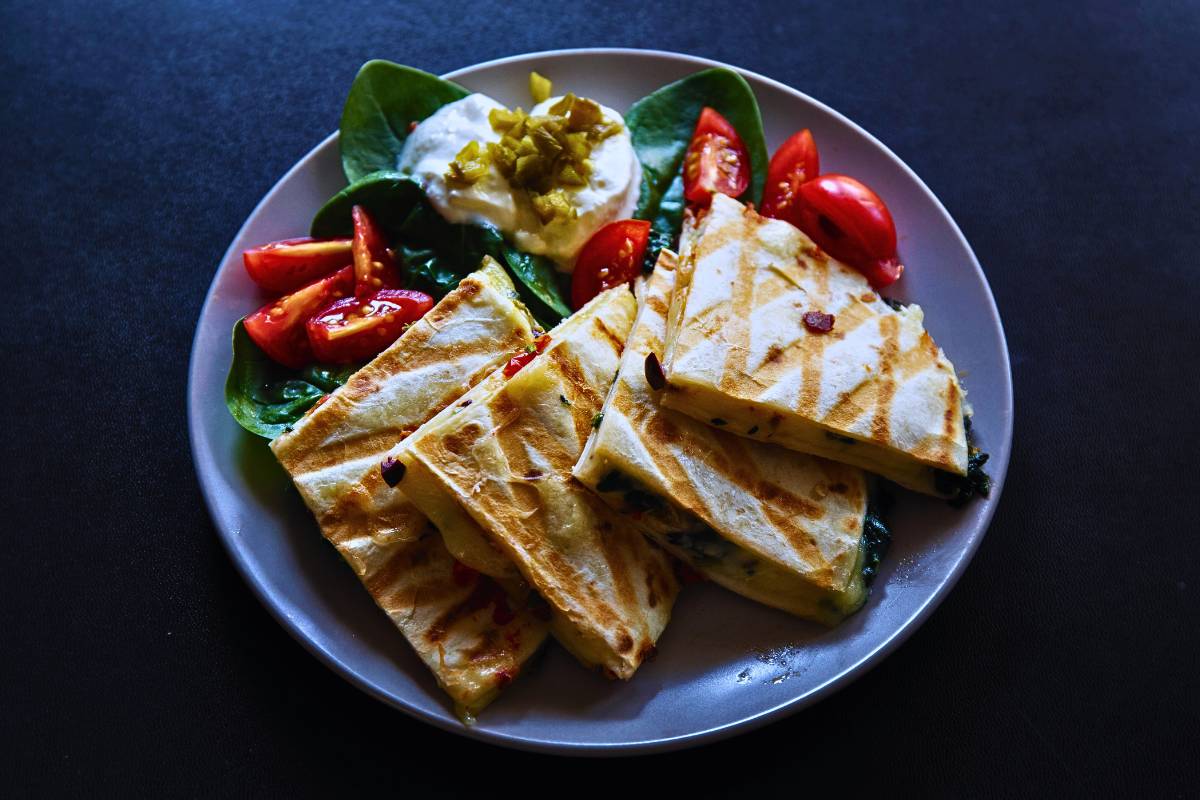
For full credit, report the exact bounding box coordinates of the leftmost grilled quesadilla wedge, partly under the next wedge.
[271,259,547,714]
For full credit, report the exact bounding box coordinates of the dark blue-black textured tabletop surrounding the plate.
[0,1,1200,796]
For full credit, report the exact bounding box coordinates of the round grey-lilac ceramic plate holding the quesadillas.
[188,50,1013,753]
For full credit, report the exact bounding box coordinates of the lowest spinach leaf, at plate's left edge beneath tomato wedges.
[226,320,359,439]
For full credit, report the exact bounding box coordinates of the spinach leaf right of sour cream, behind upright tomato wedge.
[625,67,767,242]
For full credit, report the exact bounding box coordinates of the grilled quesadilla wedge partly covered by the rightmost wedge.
[574,251,866,625]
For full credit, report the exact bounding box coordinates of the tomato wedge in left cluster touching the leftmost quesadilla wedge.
[307,289,433,363]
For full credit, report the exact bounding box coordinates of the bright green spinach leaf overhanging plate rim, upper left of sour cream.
[337,60,470,184]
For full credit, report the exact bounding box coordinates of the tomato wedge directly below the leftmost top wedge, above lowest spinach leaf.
[244,266,354,369]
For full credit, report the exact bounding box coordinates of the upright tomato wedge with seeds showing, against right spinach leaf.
[683,106,750,206]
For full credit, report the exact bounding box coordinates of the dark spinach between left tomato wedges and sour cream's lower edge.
[312,170,571,326]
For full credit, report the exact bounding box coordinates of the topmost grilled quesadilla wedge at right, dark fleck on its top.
[662,194,967,497]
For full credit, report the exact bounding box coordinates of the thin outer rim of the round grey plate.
[187,47,1014,757]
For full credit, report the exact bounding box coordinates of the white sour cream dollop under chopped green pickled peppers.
[398,94,642,272]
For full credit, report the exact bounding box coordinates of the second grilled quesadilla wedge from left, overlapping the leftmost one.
[392,287,678,679]
